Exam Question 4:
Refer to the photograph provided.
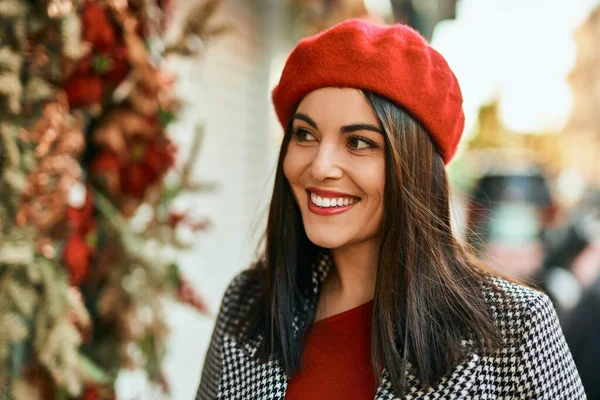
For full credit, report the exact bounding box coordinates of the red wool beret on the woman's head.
[273,20,465,164]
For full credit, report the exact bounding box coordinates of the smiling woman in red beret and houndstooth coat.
[196,20,585,400]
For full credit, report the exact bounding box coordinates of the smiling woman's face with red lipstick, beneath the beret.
[283,88,385,249]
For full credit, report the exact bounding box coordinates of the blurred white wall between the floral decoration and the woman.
[157,0,288,400]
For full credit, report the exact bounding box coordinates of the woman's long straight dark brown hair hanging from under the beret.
[240,92,501,394]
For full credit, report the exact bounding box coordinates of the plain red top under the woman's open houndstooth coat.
[285,300,377,400]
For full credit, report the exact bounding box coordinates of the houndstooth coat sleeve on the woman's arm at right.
[519,293,586,400]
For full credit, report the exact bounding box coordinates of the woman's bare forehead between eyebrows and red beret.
[296,87,379,129]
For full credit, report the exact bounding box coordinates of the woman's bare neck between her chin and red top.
[325,241,379,305]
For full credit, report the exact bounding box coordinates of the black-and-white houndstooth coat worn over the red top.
[196,257,586,400]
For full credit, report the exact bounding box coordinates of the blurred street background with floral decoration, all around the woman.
[0,0,600,400]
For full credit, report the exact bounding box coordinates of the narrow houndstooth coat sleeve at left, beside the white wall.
[195,271,246,400]
